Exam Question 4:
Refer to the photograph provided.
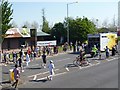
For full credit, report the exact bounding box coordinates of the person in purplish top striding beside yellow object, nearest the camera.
[12,64,20,88]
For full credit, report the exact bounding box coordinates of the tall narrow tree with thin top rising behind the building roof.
[42,9,50,33]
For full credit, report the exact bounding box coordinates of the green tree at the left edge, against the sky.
[0,0,13,35]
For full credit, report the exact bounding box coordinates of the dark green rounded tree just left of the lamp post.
[51,22,67,44]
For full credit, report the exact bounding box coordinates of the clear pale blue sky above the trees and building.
[11,2,118,27]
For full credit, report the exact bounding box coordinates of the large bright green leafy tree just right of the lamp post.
[69,17,96,43]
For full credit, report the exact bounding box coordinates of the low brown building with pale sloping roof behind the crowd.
[2,28,50,50]
